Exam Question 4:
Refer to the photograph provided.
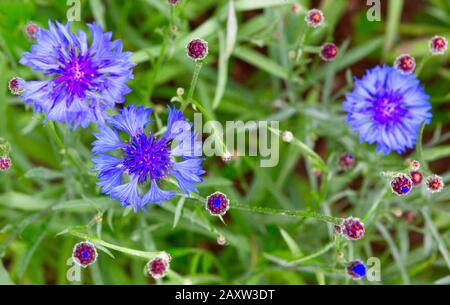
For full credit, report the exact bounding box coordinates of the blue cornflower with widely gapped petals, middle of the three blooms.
[92,106,205,211]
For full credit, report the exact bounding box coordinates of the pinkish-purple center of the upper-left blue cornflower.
[53,50,98,106]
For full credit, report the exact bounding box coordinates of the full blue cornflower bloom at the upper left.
[20,21,134,128]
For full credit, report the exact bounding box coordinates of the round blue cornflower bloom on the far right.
[343,65,432,155]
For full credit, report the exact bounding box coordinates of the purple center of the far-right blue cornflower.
[369,92,408,127]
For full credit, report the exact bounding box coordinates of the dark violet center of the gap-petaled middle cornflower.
[123,131,172,183]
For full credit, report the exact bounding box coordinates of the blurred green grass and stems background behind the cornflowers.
[0,0,450,284]
